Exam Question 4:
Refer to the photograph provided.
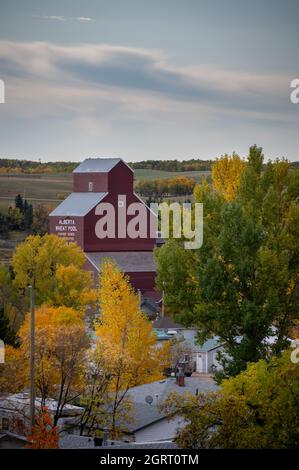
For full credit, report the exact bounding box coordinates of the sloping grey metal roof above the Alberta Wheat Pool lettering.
[50,192,108,216]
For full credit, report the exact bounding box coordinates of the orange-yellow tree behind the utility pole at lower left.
[0,306,89,425]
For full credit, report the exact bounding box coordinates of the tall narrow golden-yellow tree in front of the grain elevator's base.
[96,260,169,436]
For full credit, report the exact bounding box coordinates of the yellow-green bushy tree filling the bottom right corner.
[163,350,299,449]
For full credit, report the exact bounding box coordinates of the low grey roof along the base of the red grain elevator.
[85,251,156,273]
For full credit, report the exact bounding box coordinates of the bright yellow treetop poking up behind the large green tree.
[212,153,246,201]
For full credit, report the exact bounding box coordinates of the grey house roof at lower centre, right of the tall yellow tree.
[128,377,219,432]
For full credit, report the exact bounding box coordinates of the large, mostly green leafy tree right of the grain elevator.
[157,146,299,379]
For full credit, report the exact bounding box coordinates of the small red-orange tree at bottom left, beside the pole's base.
[27,406,59,449]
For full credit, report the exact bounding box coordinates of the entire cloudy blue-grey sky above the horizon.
[0,0,299,161]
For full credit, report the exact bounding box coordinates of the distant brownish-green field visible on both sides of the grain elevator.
[0,170,210,207]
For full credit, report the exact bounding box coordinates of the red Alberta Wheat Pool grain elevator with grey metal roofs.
[49,158,159,300]
